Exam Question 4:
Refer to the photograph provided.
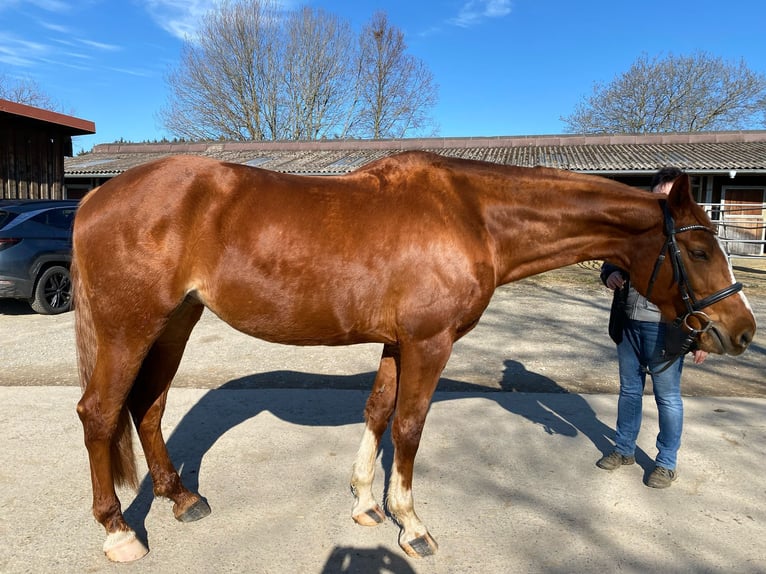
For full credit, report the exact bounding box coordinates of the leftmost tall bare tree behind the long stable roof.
[160,0,282,140]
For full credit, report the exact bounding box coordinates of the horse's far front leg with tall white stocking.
[351,345,399,526]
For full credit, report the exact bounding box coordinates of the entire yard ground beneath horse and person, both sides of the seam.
[0,266,766,574]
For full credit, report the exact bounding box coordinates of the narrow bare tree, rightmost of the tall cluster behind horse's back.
[348,12,438,139]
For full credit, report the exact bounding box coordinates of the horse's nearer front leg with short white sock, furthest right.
[386,334,453,557]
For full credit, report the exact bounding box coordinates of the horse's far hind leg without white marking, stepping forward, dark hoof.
[128,299,210,522]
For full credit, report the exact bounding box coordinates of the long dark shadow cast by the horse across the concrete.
[125,360,648,542]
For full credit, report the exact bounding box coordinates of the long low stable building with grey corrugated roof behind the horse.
[66,131,766,255]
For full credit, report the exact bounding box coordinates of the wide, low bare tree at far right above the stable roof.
[561,52,766,133]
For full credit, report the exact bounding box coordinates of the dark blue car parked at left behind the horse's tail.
[0,200,79,315]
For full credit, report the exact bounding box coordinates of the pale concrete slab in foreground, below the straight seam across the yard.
[0,387,766,574]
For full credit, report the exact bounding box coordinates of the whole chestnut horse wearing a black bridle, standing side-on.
[73,151,756,562]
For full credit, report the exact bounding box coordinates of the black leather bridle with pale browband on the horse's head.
[646,201,742,373]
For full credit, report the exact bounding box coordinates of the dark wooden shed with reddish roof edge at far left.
[0,99,96,199]
